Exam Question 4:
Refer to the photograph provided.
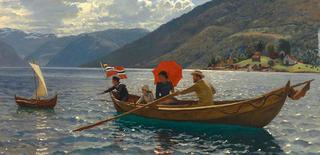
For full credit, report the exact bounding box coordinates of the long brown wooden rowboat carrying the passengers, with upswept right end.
[110,81,310,128]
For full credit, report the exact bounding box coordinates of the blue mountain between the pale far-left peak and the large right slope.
[45,29,148,67]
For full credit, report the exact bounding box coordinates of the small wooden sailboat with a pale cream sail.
[15,63,58,108]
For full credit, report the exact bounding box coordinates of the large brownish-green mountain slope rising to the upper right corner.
[84,0,320,68]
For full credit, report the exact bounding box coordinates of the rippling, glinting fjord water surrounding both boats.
[0,68,320,154]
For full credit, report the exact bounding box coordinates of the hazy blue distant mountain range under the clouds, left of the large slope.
[0,28,148,67]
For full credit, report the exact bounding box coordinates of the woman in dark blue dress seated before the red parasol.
[156,71,174,99]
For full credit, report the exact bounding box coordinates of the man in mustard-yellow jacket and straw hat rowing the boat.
[177,70,216,106]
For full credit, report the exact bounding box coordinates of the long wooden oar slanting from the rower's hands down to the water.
[73,93,176,132]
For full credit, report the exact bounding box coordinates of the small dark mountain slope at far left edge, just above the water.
[0,41,27,67]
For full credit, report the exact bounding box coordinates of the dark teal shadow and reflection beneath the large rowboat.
[115,115,284,154]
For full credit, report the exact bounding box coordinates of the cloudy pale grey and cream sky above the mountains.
[0,0,209,36]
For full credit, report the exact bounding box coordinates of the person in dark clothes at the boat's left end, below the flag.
[100,76,129,101]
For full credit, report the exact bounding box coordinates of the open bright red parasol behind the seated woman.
[152,61,182,86]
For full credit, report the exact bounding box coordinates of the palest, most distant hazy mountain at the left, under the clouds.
[0,28,57,58]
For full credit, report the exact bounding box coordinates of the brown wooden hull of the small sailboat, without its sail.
[15,95,58,108]
